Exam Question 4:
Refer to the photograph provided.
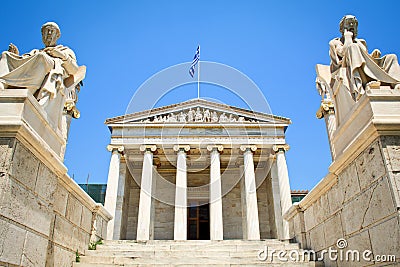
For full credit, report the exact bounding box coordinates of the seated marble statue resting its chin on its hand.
[329,15,400,101]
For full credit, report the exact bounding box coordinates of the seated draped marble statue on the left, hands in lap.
[0,22,86,126]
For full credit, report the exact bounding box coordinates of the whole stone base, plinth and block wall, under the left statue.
[0,89,111,266]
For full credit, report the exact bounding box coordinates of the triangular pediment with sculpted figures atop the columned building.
[105,99,291,125]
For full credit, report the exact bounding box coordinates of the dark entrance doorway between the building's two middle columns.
[187,204,210,240]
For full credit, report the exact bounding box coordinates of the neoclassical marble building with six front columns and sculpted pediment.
[105,99,291,240]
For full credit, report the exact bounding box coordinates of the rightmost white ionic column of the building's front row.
[271,145,292,240]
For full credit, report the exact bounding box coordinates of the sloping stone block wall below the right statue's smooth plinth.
[285,136,400,266]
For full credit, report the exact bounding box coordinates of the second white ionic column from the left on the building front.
[136,145,157,240]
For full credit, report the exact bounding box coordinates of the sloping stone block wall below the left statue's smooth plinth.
[0,137,110,266]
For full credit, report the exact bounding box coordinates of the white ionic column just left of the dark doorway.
[174,145,190,240]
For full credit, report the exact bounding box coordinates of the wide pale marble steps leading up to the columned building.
[73,239,324,267]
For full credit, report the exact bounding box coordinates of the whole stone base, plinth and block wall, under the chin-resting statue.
[285,87,400,266]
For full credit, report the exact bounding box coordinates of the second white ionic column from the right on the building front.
[240,146,260,240]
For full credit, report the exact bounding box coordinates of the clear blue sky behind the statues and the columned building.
[0,0,400,189]
